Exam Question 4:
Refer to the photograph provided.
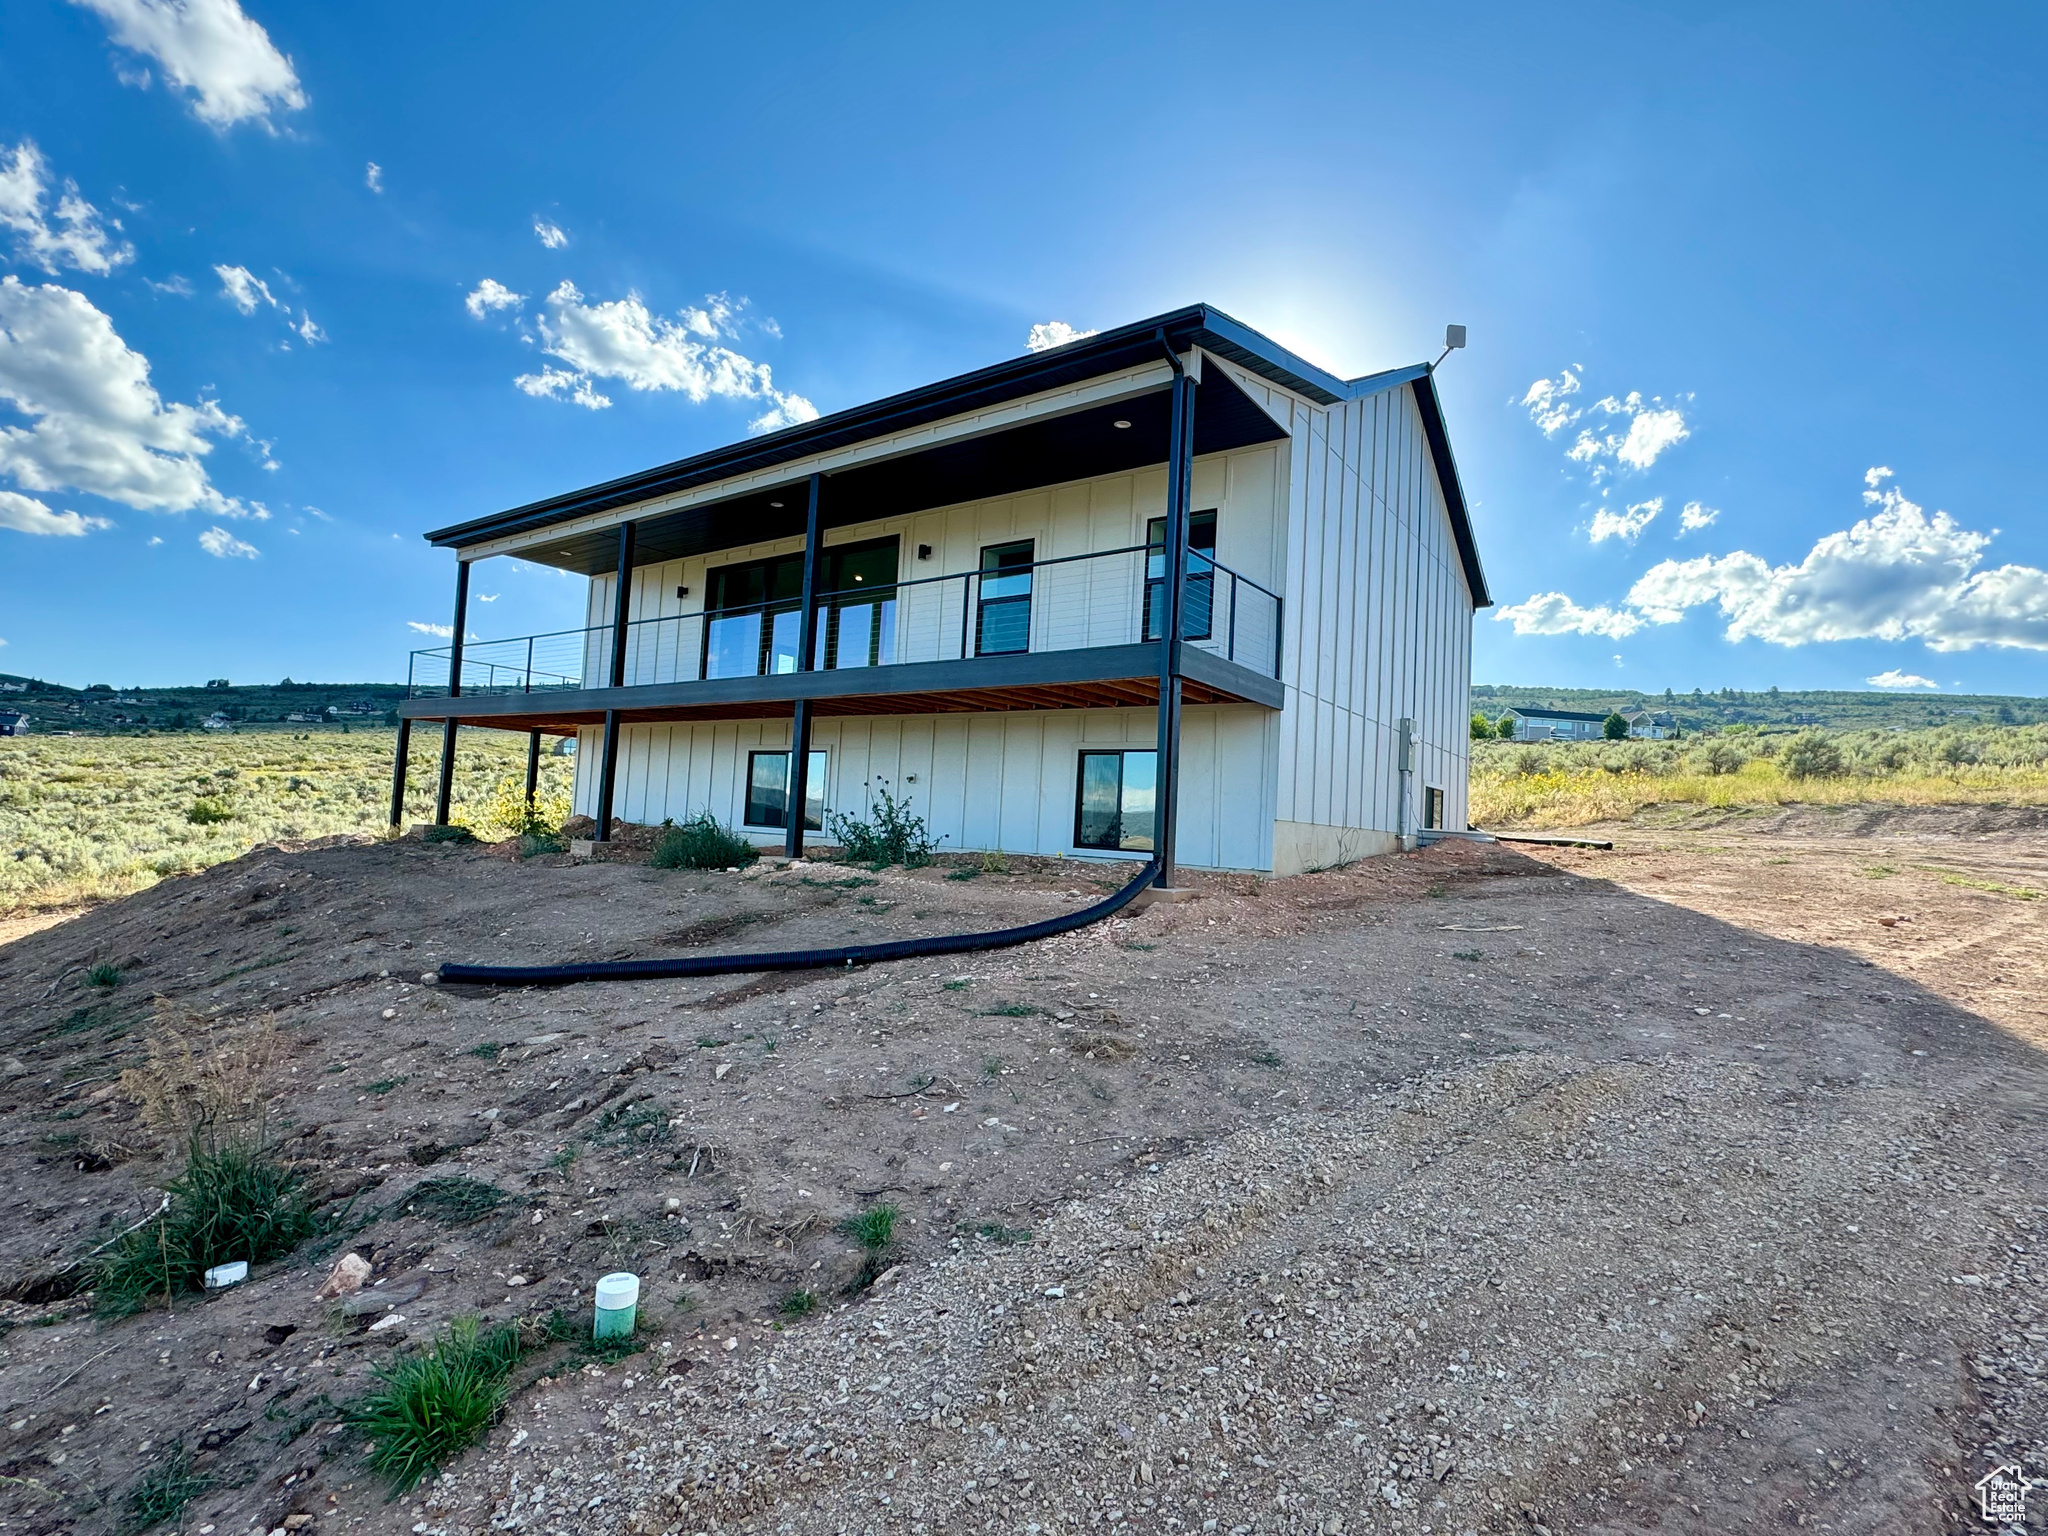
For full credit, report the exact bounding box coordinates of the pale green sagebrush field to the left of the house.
[0,729,575,915]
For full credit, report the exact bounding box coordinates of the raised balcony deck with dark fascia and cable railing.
[399,547,1282,731]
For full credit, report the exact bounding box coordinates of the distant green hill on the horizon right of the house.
[1473,682,2048,731]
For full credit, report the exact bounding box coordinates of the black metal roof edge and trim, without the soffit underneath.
[426,303,1493,608]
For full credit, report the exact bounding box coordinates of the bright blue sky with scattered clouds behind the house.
[0,0,2048,694]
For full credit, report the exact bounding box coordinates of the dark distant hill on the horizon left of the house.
[0,672,406,735]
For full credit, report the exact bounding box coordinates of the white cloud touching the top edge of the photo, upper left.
[72,0,305,129]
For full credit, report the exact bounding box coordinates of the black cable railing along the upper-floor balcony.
[408,545,1282,698]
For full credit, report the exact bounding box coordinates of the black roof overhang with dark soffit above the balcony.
[428,305,1491,606]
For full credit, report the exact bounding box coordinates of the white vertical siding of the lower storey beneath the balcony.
[575,705,1278,870]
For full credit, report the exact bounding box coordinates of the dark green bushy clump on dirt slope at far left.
[94,1137,315,1317]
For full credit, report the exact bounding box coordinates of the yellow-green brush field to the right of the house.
[1473,725,2048,827]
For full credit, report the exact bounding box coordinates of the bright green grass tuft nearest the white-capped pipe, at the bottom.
[348,1317,522,1497]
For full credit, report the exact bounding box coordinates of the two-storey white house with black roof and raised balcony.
[391,305,1491,885]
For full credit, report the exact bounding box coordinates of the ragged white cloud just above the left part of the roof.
[512,283,817,432]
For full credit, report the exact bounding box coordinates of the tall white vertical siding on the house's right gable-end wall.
[1208,358,1473,874]
